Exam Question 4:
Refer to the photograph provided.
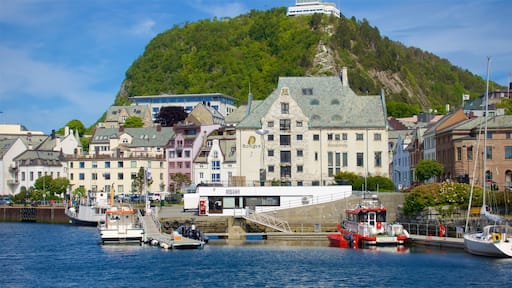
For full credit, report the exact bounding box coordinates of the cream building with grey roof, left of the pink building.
[67,125,174,194]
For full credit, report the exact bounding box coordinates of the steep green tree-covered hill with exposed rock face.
[115,7,498,116]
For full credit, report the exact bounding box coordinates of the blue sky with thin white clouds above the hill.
[0,0,512,133]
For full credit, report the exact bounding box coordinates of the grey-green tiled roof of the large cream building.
[237,77,386,129]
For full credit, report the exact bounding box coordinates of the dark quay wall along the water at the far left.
[0,206,69,224]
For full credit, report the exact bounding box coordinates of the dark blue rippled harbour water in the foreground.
[0,223,512,288]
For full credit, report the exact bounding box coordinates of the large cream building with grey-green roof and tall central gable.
[236,69,389,186]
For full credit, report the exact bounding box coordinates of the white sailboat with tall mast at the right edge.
[464,59,512,257]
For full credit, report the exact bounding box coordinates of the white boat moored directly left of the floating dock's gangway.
[98,206,144,244]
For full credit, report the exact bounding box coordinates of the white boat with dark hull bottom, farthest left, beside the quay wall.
[65,191,112,226]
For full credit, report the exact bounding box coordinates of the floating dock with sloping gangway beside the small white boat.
[140,213,205,249]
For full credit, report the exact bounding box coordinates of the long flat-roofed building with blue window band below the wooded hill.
[129,93,236,121]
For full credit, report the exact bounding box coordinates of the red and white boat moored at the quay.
[327,195,410,248]
